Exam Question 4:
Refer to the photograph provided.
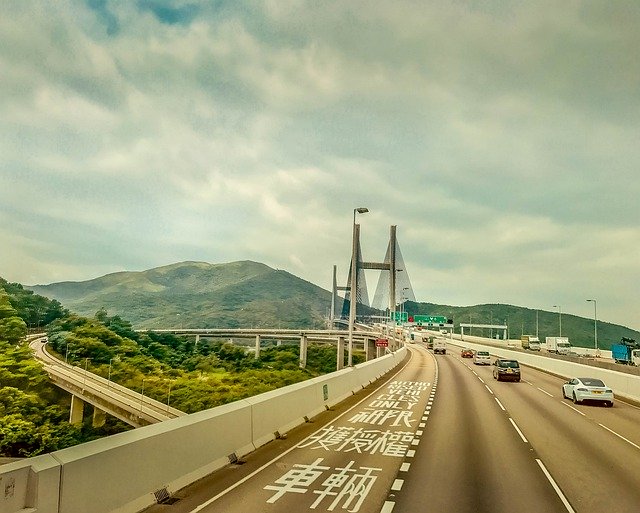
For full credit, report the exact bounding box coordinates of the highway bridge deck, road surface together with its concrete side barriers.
[0,332,640,513]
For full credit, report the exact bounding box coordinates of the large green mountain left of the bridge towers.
[27,261,342,328]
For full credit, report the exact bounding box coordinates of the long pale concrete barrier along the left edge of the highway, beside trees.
[0,348,406,513]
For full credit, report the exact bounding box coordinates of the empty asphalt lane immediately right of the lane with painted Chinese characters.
[393,353,570,513]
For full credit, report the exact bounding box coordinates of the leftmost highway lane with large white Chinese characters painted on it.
[147,349,435,513]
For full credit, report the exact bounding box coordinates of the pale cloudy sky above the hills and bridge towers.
[0,0,640,329]
